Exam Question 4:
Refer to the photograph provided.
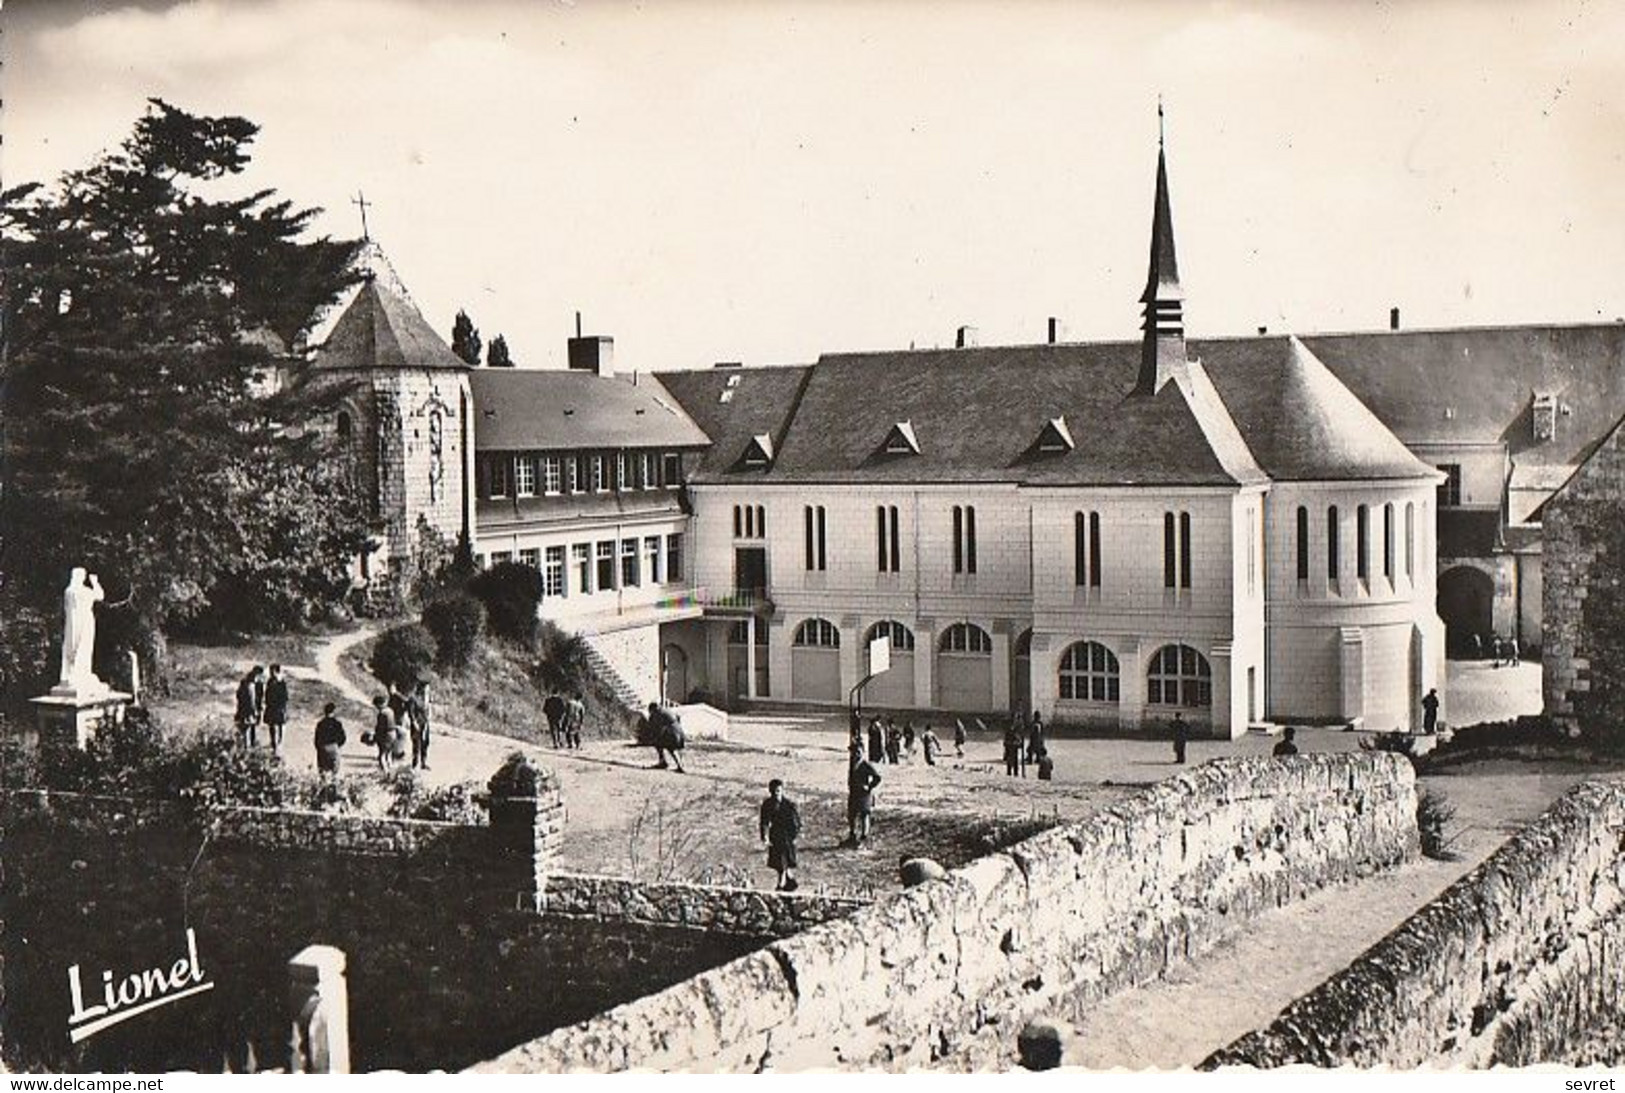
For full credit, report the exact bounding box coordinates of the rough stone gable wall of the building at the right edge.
[1541,427,1625,731]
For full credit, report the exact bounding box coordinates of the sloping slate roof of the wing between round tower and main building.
[468,369,710,451]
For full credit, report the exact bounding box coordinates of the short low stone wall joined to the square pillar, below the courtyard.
[543,874,868,937]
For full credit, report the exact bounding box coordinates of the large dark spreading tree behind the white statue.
[0,99,366,676]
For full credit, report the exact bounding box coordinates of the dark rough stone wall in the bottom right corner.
[1204,781,1625,1067]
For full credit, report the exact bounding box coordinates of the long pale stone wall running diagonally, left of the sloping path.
[476,754,1417,1072]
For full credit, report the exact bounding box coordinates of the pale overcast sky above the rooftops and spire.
[9,0,1625,369]
